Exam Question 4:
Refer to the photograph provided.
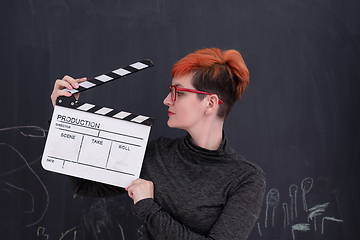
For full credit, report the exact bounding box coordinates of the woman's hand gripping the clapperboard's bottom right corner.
[125,178,154,204]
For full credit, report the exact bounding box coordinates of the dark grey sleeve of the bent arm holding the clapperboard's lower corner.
[134,168,266,240]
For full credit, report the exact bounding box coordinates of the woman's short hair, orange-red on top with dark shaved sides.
[171,48,250,117]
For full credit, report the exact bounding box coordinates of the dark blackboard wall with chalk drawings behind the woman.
[0,0,360,240]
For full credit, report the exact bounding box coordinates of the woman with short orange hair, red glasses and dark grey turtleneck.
[51,48,266,240]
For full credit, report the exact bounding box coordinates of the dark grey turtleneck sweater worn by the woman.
[71,134,266,240]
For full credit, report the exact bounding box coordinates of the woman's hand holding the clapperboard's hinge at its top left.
[51,76,86,106]
